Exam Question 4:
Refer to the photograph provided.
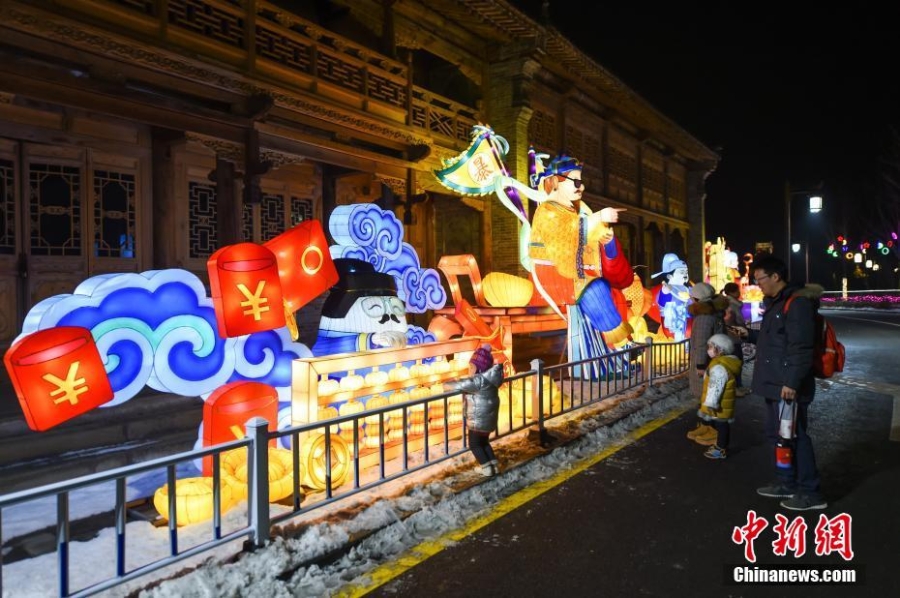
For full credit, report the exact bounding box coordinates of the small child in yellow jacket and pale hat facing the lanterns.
[688,334,743,459]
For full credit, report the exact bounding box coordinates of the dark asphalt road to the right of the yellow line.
[356,312,900,598]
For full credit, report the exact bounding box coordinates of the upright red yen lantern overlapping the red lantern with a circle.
[206,243,285,338]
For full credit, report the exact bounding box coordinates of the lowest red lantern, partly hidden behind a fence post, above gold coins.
[203,381,278,476]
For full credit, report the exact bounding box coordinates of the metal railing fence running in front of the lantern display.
[0,339,689,596]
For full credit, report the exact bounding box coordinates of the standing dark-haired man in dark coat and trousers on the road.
[740,255,828,511]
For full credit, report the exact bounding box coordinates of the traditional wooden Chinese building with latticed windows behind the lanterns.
[0,0,718,346]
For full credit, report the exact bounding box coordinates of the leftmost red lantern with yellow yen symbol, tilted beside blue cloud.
[3,326,113,432]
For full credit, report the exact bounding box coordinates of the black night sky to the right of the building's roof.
[513,0,900,278]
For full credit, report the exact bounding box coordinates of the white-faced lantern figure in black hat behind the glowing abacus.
[312,258,407,357]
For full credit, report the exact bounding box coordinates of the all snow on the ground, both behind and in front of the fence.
[3,378,693,598]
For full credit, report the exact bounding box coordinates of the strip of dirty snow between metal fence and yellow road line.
[140,380,693,598]
